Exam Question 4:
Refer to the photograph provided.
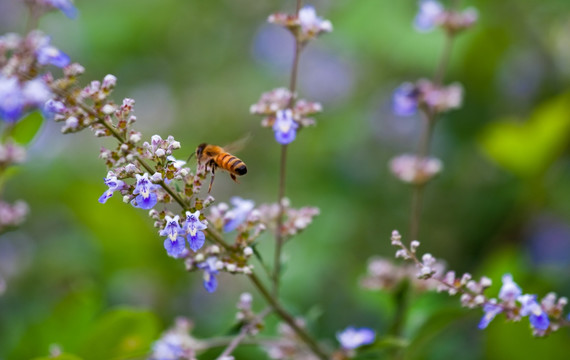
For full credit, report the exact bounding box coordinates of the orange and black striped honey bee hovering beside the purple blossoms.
[196,143,247,193]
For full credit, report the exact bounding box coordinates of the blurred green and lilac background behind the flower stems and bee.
[0,0,570,360]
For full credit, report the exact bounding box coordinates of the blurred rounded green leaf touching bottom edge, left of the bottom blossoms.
[79,308,160,359]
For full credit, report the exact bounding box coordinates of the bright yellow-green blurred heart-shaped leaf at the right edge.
[480,94,570,178]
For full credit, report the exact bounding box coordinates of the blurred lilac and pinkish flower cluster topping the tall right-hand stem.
[414,0,478,34]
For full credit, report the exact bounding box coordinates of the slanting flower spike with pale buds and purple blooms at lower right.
[391,231,570,336]
